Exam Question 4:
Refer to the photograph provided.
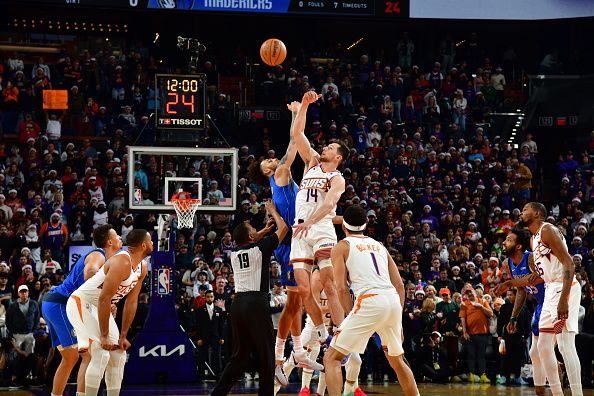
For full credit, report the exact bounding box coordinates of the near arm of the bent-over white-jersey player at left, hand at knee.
[97,255,130,350]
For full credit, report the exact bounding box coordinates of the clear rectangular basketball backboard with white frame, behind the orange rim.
[128,146,238,213]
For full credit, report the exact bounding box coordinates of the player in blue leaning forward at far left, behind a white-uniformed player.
[41,224,122,396]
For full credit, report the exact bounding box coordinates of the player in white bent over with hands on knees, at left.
[66,229,153,396]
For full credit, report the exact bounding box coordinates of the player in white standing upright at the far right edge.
[520,202,583,396]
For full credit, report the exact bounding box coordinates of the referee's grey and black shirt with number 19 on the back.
[231,234,278,293]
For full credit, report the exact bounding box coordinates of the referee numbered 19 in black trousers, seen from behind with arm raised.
[211,200,289,396]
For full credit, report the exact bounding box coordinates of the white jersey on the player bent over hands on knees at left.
[72,250,144,306]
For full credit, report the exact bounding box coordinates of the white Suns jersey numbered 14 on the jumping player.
[295,164,342,221]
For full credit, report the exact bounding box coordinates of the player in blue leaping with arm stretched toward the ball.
[249,102,323,386]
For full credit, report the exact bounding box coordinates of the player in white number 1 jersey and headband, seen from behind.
[324,205,419,396]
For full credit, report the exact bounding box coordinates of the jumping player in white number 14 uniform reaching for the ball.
[290,91,349,346]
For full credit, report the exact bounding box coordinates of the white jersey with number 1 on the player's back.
[344,236,396,297]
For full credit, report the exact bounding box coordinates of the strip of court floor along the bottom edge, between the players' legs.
[12,383,594,396]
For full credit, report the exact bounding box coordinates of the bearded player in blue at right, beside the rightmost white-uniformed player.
[495,228,546,395]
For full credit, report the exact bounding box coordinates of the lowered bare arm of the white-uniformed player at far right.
[542,226,575,320]
